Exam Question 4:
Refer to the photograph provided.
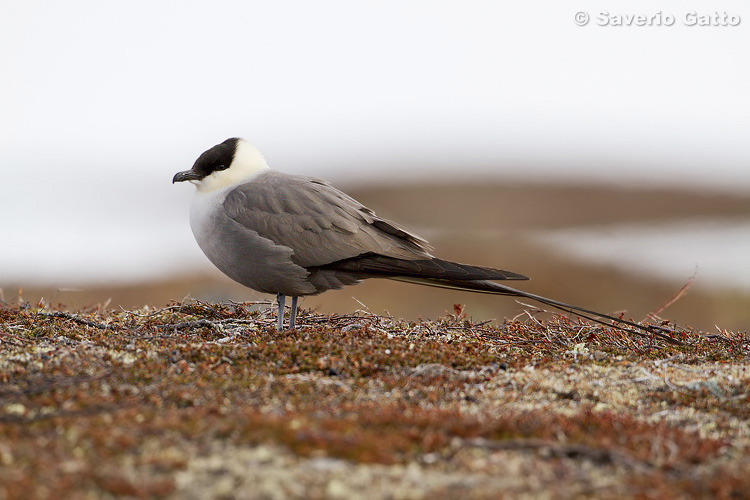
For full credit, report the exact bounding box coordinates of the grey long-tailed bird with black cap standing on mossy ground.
[172,137,658,335]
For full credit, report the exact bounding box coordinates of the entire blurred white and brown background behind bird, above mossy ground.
[0,0,750,330]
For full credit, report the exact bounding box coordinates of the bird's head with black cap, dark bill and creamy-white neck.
[172,137,268,191]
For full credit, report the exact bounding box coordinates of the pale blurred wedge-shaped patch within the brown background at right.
[536,219,750,290]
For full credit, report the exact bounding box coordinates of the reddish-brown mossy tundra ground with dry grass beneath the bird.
[0,301,750,499]
